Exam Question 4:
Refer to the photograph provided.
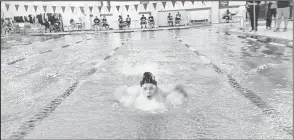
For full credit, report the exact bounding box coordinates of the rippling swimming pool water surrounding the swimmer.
[1,27,293,139]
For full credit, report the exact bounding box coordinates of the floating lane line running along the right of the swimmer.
[172,35,293,136]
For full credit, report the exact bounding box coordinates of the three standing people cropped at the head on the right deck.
[246,1,291,32]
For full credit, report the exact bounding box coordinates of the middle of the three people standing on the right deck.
[266,1,277,30]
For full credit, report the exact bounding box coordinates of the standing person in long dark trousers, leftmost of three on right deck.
[247,1,260,32]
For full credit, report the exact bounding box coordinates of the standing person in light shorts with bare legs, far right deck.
[274,1,290,32]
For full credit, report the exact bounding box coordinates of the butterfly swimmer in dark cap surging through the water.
[115,72,188,110]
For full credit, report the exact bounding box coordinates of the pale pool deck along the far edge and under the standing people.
[1,21,293,48]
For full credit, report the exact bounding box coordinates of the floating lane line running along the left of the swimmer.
[8,33,132,139]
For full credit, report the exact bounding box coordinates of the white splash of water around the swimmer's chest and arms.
[113,84,188,113]
